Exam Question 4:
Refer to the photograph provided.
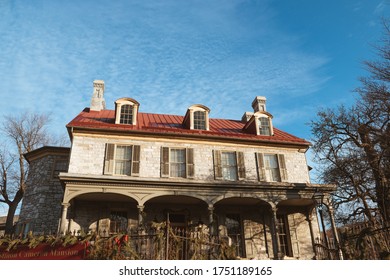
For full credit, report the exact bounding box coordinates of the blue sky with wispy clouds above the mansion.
[0,0,390,203]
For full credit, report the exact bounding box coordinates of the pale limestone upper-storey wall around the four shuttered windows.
[69,134,309,183]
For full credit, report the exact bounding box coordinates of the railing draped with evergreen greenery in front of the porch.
[81,223,236,260]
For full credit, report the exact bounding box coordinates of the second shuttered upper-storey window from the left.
[161,147,194,178]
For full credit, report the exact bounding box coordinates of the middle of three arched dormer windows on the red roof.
[183,104,210,130]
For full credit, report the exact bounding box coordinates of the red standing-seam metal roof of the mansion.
[67,108,310,146]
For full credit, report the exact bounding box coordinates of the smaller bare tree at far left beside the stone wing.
[0,113,52,234]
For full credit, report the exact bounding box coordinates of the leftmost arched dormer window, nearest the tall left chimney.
[115,98,139,125]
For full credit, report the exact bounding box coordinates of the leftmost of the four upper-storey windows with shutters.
[104,144,140,176]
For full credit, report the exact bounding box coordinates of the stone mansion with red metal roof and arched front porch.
[19,80,334,259]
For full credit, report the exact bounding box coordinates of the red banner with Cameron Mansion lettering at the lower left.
[0,243,86,260]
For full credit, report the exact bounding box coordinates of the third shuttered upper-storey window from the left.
[214,151,245,181]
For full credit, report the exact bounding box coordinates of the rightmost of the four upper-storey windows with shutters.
[256,153,287,182]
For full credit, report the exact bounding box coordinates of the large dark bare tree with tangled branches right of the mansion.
[311,23,390,225]
